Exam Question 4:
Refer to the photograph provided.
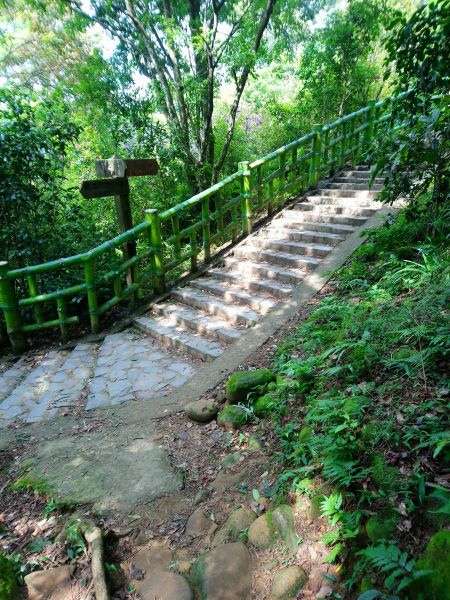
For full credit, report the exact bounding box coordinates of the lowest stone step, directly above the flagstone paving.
[134,316,225,362]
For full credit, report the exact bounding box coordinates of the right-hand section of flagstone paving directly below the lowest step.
[86,331,195,410]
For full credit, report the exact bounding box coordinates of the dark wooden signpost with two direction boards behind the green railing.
[80,156,159,268]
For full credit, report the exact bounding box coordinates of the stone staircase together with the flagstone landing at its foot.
[0,167,382,427]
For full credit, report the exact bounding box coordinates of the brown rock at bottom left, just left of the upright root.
[24,565,75,600]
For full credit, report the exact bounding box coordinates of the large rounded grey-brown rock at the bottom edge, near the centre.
[191,542,252,600]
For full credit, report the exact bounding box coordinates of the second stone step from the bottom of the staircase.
[153,302,242,344]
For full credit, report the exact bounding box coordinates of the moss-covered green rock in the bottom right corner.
[408,531,450,600]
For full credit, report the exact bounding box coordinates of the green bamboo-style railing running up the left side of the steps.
[0,92,408,353]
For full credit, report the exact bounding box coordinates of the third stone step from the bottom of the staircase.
[171,287,260,327]
